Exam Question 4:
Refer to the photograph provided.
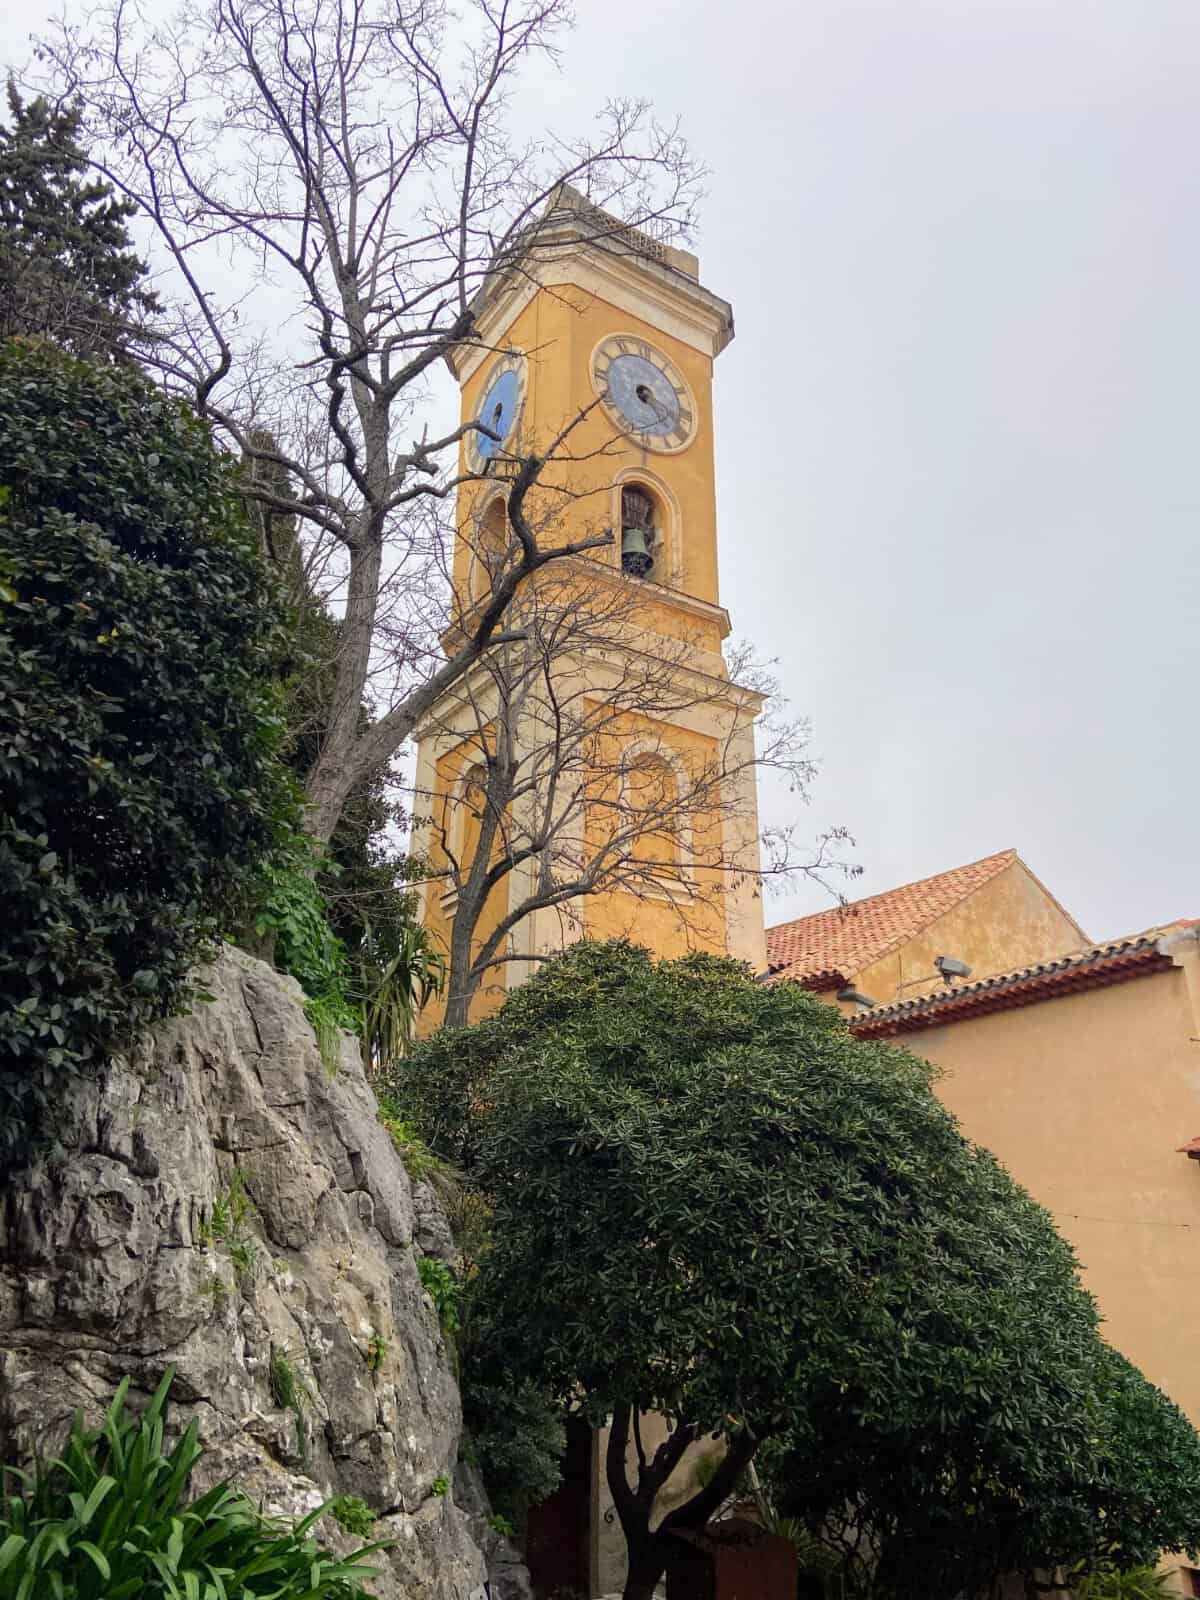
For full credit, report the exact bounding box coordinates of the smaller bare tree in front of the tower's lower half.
[414,508,846,1026]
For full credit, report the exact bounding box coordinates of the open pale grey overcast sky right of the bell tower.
[0,0,1200,938]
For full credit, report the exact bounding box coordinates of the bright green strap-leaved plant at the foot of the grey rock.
[0,1371,382,1600]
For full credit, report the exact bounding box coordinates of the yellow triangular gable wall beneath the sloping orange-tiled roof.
[843,861,1088,1010]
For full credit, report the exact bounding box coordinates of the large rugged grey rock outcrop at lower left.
[0,950,524,1600]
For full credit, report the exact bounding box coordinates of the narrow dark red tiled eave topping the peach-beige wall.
[850,923,1200,1036]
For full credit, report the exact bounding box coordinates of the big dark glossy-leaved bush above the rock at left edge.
[0,342,291,1141]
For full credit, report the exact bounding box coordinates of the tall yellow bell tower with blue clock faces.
[413,186,765,1027]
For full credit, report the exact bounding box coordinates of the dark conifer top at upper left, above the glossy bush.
[0,82,158,357]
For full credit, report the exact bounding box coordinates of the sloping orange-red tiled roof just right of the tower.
[766,850,1018,990]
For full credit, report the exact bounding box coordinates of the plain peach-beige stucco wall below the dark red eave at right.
[899,957,1200,1426]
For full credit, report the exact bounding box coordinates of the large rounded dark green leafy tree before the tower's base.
[394,942,1200,1597]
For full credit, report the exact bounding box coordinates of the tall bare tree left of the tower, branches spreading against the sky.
[42,0,699,840]
